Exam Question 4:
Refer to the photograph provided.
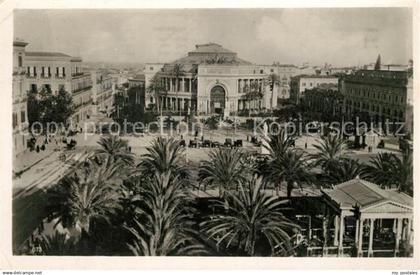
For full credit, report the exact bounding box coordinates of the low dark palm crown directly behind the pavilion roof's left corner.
[324,158,364,185]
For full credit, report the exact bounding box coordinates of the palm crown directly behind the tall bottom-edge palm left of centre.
[138,137,189,178]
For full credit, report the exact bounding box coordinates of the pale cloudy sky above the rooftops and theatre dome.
[14,8,413,66]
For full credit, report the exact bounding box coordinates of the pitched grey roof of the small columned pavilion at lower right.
[322,178,413,211]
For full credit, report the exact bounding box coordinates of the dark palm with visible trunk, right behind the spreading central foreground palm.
[265,148,313,198]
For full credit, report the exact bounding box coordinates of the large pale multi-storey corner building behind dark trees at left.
[25,52,92,128]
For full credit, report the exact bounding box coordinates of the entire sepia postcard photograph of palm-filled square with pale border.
[2,0,419,268]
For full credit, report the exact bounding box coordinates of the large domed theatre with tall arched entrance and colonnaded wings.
[145,43,286,117]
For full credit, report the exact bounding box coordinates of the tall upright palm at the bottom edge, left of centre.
[127,171,204,256]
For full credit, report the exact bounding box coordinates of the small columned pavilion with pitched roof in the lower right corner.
[322,178,413,257]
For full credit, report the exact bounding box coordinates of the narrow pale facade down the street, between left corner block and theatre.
[90,70,114,117]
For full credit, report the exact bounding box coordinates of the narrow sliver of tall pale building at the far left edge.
[12,41,29,156]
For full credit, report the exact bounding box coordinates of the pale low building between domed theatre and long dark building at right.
[290,75,339,104]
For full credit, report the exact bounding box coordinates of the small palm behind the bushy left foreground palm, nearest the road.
[95,135,134,166]
